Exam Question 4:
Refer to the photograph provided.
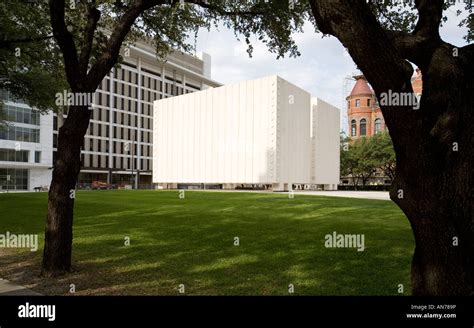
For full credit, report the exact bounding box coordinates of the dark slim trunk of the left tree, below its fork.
[41,107,90,276]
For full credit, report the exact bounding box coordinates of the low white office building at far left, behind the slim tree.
[0,90,53,191]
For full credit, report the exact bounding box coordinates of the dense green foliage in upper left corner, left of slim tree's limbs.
[0,0,67,113]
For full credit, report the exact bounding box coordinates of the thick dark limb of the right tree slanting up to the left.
[310,0,420,149]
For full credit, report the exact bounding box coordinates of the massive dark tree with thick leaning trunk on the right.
[309,0,474,295]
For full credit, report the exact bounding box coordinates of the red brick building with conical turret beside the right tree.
[346,68,423,138]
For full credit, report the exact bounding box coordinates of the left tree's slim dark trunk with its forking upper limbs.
[41,0,143,276]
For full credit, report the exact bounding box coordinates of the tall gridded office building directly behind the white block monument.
[54,43,220,188]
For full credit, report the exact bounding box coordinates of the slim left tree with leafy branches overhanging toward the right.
[31,0,309,276]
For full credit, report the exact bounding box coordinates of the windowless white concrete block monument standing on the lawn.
[153,76,339,190]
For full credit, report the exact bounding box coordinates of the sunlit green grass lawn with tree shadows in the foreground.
[0,191,414,295]
